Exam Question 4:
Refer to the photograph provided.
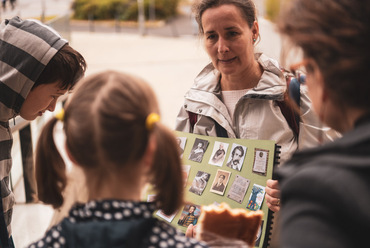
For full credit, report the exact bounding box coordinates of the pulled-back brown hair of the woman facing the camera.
[192,0,257,34]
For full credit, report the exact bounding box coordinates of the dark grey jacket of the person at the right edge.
[278,116,370,248]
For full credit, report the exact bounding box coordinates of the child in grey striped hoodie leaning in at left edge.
[0,17,86,247]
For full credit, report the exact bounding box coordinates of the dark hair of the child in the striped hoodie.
[32,44,86,90]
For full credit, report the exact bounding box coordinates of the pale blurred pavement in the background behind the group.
[0,0,281,247]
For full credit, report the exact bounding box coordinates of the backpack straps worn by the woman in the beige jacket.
[187,72,306,138]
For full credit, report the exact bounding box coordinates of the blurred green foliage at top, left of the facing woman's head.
[72,0,179,21]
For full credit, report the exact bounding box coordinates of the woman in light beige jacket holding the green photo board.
[176,0,337,211]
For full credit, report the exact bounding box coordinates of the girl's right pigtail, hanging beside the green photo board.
[152,123,184,215]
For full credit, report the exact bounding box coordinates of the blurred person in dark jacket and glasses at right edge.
[279,0,370,248]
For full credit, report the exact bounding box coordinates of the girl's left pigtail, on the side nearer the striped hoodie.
[36,118,67,208]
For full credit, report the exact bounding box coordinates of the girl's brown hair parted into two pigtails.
[36,71,183,214]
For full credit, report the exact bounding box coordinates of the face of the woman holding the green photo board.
[202,4,258,75]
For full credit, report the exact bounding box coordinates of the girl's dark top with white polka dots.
[29,200,208,248]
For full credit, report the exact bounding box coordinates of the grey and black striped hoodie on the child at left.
[0,17,67,240]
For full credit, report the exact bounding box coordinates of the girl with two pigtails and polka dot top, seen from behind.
[30,71,207,248]
